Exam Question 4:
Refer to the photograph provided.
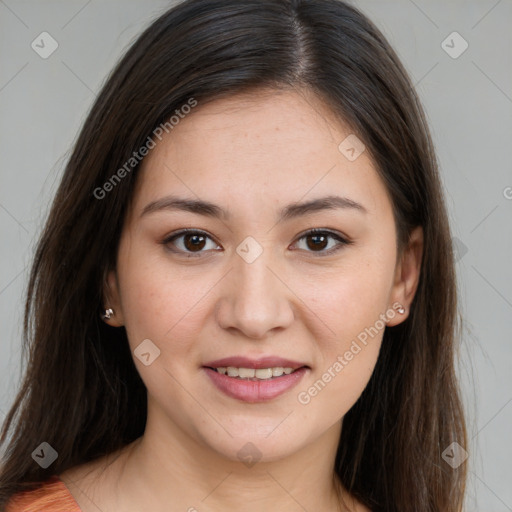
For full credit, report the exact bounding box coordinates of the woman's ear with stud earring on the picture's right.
[387,226,423,327]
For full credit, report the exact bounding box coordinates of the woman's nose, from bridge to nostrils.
[216,251,295,339]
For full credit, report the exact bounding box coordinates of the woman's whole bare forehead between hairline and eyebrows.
[130,91,386,220]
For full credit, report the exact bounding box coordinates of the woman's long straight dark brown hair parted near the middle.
[0,0,466,512]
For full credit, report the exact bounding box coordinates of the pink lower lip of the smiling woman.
[203,367,308,403]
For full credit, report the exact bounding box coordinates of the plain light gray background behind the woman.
[0,0,512,512]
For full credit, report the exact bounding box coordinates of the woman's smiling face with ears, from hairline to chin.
[105,92,421,460]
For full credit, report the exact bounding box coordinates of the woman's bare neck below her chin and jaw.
[113,408,343,512]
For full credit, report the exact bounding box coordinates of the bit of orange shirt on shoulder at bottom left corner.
[5,475,81,512]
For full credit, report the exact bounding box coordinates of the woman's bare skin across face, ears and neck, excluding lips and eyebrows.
[61,90,423,512]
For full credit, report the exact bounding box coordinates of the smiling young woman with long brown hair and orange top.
[0,0,466,512]
